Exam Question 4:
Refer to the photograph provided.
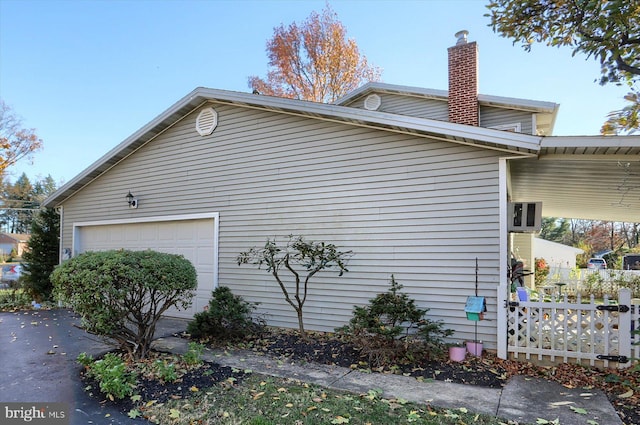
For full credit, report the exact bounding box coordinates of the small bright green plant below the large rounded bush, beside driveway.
[78,353,137,400]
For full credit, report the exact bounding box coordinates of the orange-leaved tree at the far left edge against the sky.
[0,100,42,176]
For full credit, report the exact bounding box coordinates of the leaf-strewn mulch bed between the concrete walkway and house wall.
[226,330,640,425]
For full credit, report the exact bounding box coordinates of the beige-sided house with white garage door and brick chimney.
[44,32,640,354]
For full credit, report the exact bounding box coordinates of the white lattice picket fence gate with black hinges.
[507,288,640,368]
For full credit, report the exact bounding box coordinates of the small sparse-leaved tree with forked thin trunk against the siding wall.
[237,235,352,337]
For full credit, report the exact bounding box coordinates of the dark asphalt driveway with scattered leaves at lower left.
[0,309,133,425]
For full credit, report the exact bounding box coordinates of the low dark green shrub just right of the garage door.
[187,286,259,340]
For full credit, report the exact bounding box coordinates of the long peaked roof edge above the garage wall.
[43,87,542,207]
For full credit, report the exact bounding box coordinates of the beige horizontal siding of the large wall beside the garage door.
[57,104,499,347]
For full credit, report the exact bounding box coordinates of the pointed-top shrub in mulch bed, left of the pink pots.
[336,275,453,366]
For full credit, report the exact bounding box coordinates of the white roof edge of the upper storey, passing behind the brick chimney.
[334,82,560,136]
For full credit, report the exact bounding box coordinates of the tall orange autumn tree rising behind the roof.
[249,5,381,103]
